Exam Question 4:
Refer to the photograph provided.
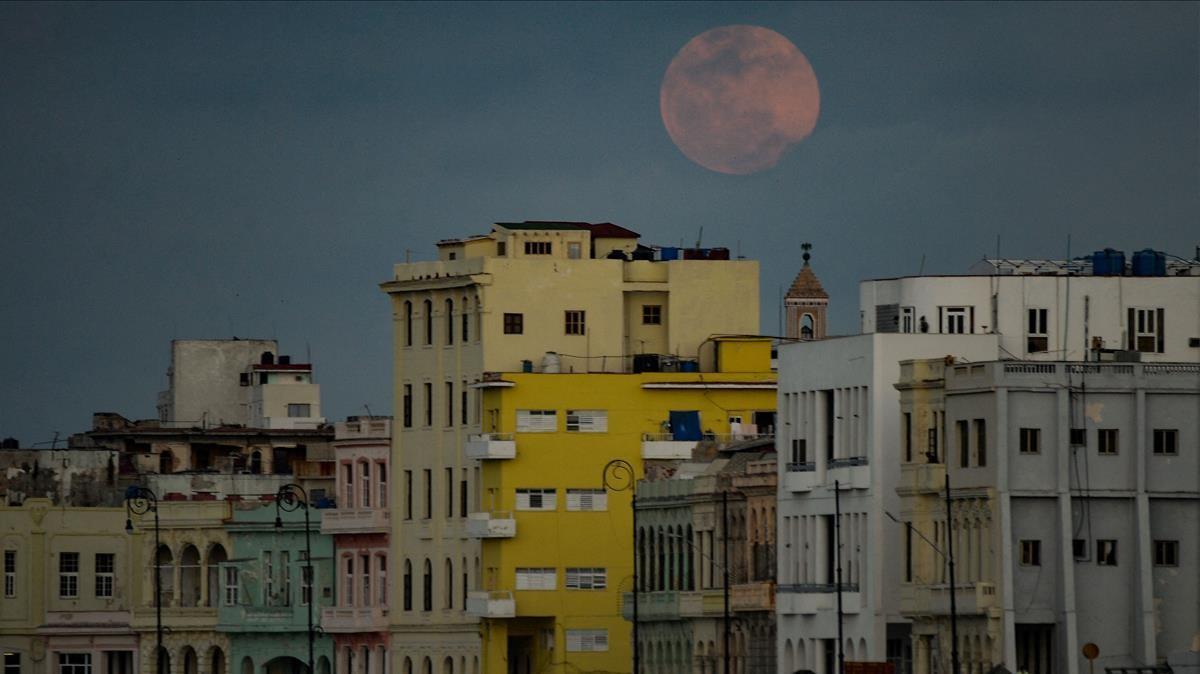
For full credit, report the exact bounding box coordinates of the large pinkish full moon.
[659,25,821,174]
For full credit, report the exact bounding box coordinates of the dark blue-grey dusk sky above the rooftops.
[0,2,1200,446]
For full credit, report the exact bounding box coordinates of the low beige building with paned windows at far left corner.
[0,498,143,674]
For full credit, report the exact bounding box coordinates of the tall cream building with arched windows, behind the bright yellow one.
[382,222,758,674]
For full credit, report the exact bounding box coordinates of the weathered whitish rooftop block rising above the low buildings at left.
[158,339,325,429]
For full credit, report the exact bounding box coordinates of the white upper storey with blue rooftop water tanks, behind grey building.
[859,253,1200,362]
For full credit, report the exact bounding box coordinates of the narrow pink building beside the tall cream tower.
[320,416,391,674]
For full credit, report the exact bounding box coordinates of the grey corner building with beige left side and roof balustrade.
[898,361,1200,674]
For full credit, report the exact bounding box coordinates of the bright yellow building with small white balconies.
[467,339,775,673]
